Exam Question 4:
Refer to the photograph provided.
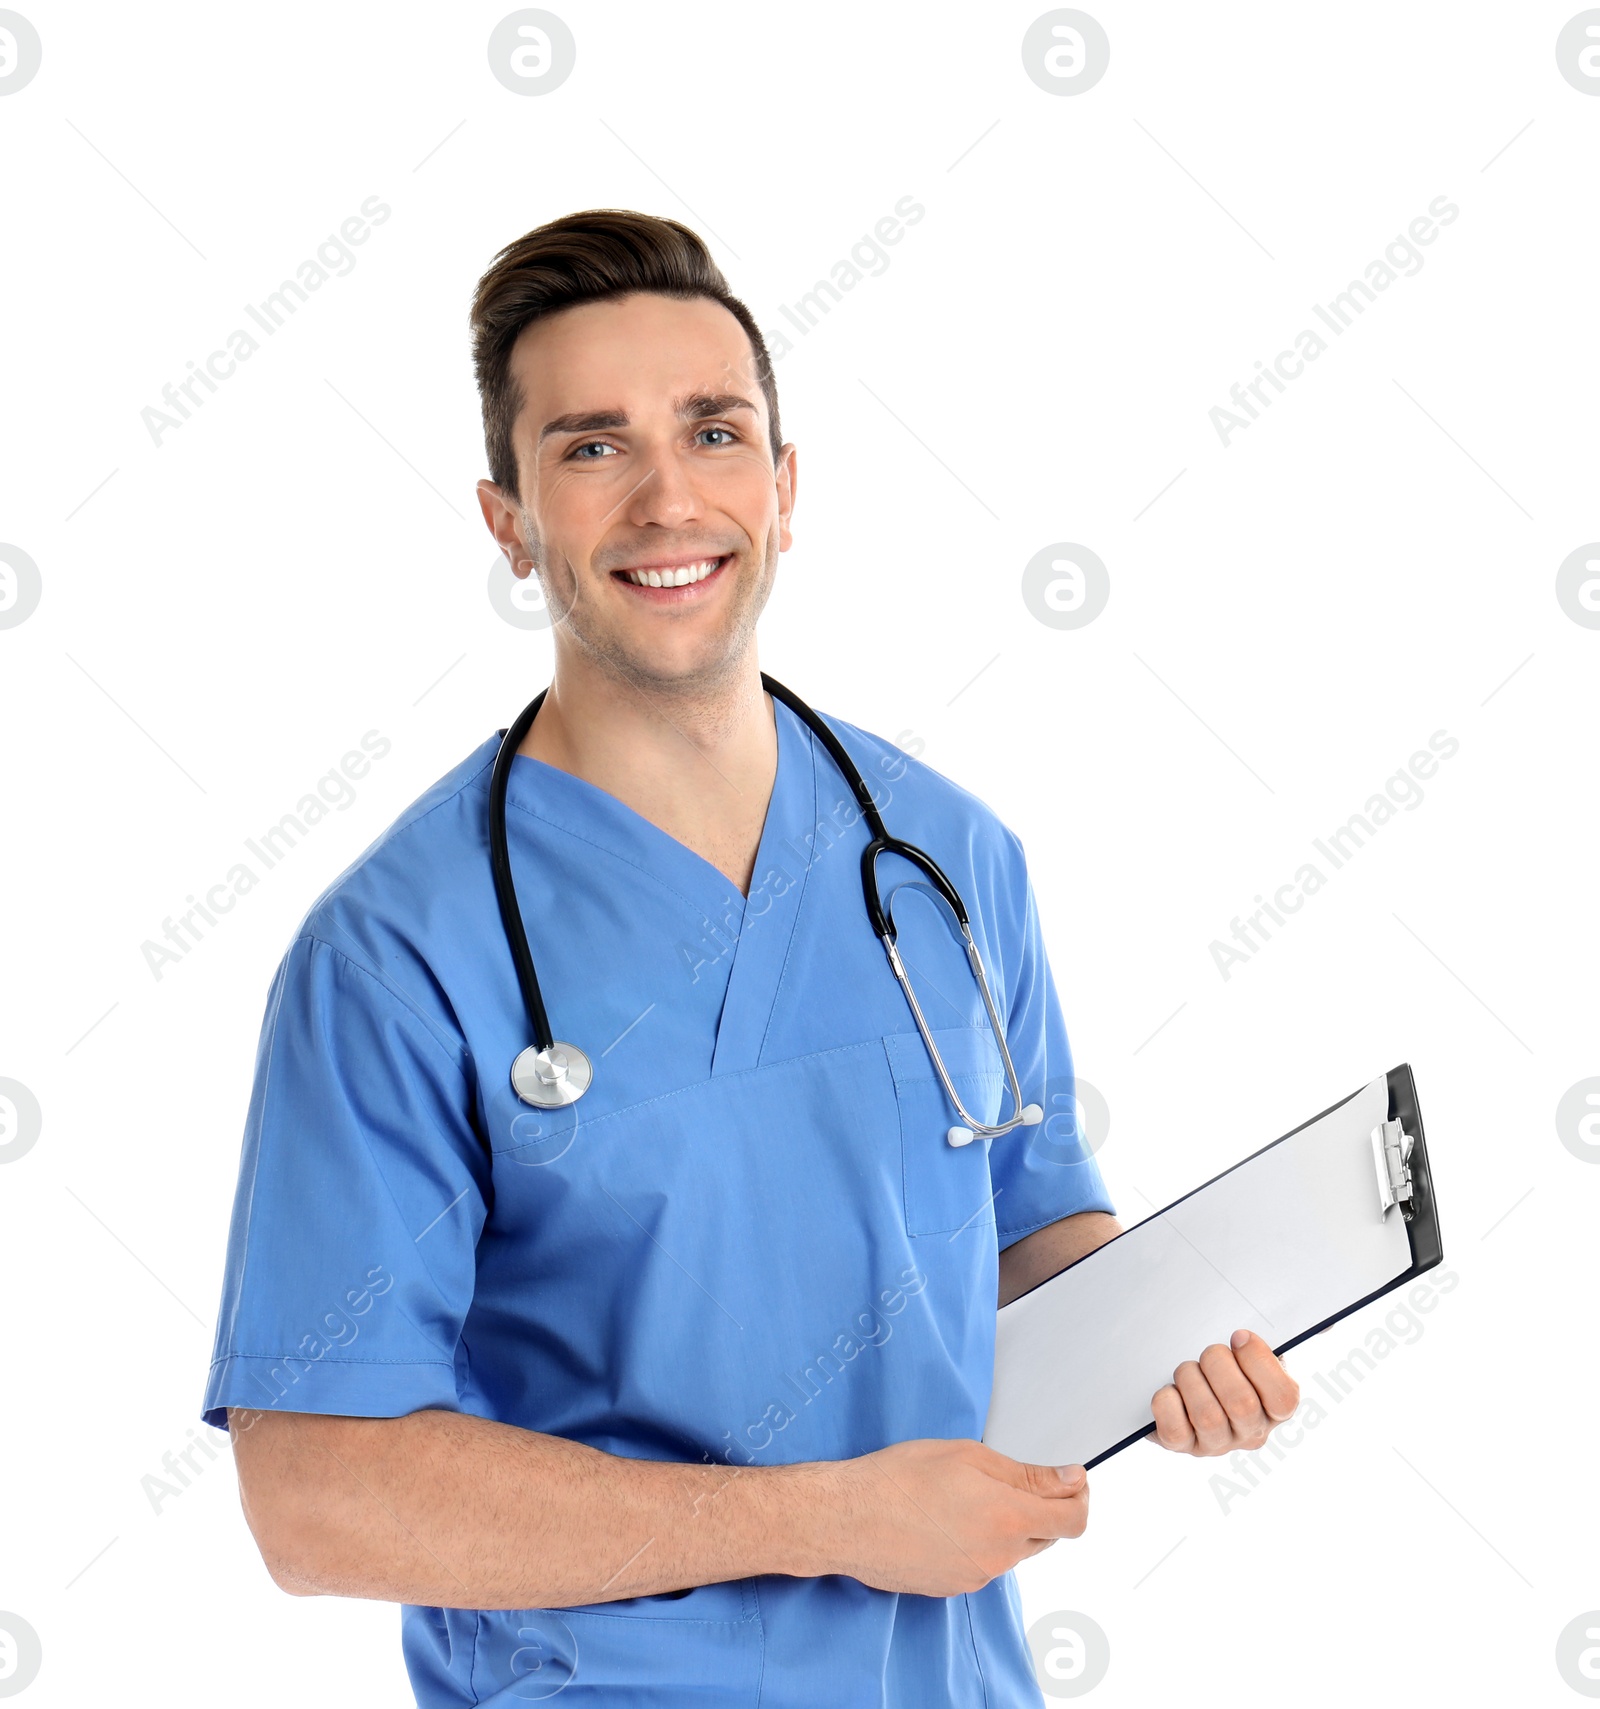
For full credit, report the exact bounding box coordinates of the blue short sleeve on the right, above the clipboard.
[990,868,1115,1251]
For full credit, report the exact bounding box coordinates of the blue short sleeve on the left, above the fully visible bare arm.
[202,935,489,1429]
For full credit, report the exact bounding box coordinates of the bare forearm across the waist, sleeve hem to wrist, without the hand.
[232,1412,838,1608]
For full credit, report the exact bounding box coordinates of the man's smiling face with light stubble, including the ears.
[479,292,795,687]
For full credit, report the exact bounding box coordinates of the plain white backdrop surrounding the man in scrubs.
[0,0,1600,1706]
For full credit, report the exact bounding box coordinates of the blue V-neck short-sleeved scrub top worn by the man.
[203,704,1111,1709]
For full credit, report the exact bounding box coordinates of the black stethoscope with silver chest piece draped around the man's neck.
[489,672,1044,1145]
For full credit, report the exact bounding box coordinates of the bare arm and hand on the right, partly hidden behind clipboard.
[1000,1210,1299,1458]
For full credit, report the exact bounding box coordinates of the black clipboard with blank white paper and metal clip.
[983,1063,1444,1468]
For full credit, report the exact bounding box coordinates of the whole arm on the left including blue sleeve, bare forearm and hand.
[218,933,1087,1608]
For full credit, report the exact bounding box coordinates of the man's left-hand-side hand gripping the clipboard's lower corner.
[814,1439,1089,1596]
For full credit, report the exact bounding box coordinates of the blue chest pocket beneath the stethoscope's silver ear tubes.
[884,1027,1005,1237]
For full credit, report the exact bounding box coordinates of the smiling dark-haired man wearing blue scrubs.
[205,210,1297,1709]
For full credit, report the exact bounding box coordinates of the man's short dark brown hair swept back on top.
[470,208,783,497]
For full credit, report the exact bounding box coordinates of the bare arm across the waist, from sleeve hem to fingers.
[229,1408,1089,1608]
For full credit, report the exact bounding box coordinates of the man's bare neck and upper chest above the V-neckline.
[518,648,778,892]
